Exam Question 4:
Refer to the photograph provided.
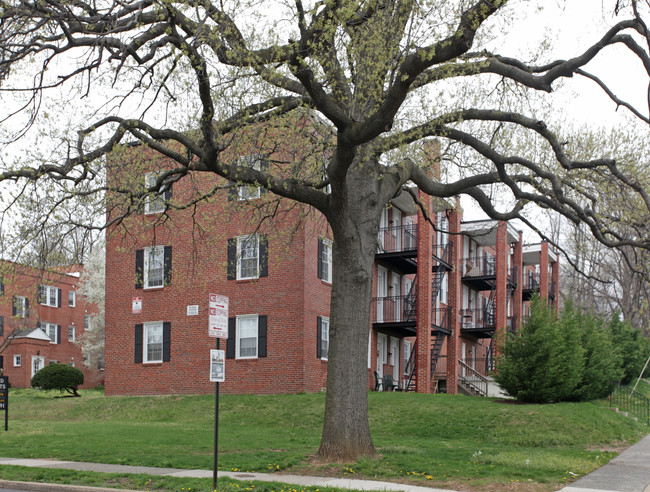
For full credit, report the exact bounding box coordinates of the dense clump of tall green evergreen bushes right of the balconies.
[495,299,624,403]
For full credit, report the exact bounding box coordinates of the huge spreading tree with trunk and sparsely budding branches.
[0,0,650,460]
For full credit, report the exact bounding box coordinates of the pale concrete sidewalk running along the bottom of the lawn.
[0,434,650,492]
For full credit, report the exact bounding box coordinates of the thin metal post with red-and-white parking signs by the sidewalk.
[208,294,228,491]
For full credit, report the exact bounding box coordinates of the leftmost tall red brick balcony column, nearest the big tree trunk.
[415,191,433,393]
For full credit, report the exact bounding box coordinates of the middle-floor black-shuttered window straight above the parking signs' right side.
[228,234,268,280]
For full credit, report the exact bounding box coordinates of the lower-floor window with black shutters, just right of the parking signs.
[226,314,267,359]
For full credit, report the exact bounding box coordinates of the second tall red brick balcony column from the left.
[447,198,463,395]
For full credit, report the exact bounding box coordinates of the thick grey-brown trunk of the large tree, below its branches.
[317,153,382,462]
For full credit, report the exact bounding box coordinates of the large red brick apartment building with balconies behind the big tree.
[105,131,558,395]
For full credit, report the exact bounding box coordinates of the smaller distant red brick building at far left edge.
[0,261,101,388]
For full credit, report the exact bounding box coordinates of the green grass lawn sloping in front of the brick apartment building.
[0,389,648,491]
